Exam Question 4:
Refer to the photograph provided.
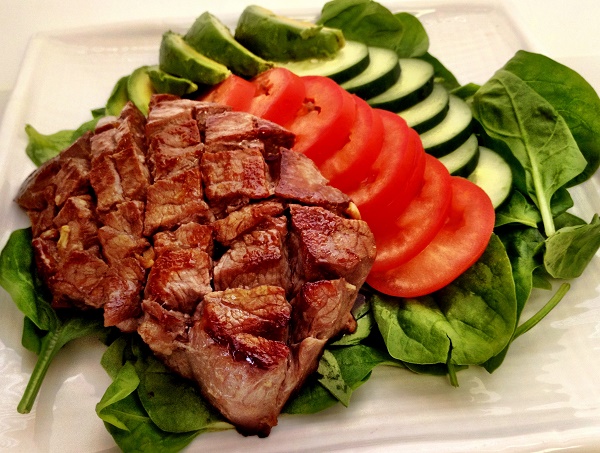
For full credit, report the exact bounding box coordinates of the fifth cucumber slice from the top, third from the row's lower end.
[421,94,473,157]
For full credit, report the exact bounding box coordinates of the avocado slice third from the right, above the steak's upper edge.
[158,31,231,85]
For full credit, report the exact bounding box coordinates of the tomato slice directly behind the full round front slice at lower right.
[371,154,452,272]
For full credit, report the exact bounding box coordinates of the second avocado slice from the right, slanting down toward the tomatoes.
[183,12,273,78]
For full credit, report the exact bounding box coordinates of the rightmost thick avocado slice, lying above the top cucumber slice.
[235,5,345,61]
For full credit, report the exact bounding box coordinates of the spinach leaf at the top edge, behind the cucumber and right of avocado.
[317,0,429,58]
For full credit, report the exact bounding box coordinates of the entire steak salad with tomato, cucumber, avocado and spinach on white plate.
[0,0,600,451]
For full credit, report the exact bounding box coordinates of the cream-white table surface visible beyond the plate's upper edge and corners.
[0,0,600,449]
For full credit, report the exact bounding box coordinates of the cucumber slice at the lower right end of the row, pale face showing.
[467,146,512,208]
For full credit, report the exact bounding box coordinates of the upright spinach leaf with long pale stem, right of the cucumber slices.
[473,69,586,236]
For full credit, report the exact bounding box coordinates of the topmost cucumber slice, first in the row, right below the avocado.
[277,41,369,83]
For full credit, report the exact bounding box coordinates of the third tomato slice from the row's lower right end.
[346,109,414,224]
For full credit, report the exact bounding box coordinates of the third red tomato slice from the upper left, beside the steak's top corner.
[288,76,356,166]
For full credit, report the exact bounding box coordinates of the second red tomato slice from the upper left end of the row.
[247,67,305,126]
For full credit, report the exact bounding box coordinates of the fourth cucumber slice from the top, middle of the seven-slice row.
[398,83,449,134]
